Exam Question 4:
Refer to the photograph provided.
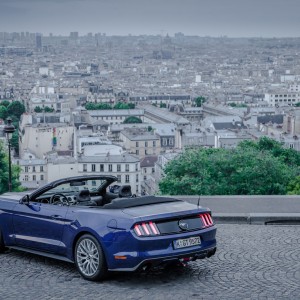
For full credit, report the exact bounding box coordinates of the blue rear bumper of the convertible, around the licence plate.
[108,226,216,271]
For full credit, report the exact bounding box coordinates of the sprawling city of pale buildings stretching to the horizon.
[0,32,300,194]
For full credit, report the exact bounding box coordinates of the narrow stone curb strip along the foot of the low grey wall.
[212,213,300,225]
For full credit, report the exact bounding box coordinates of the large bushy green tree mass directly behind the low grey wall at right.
[160,137,300,195]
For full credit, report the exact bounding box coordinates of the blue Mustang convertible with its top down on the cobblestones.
[0,175,216,280]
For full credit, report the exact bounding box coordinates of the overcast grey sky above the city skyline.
[0,0,300,37]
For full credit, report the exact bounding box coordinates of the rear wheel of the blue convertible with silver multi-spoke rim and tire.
[74,234,108,281]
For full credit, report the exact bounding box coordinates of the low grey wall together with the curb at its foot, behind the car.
[176,195,300,225]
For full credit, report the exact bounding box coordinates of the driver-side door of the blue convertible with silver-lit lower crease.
[13,202,68,254]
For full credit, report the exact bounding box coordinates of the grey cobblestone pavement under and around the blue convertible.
[0,224,300,300]
